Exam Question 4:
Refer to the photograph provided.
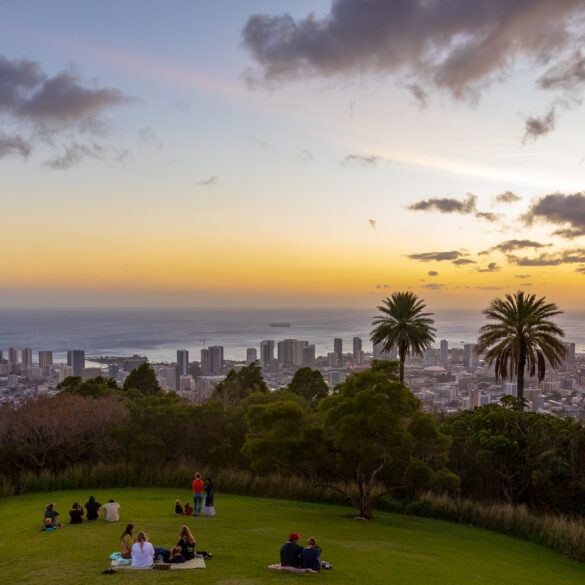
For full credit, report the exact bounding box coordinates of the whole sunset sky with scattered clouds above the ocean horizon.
[0,0,585,309]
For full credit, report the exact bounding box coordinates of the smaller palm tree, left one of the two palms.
[371,291,436,382]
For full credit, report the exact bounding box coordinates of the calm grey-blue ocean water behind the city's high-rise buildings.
[0,308,585,362]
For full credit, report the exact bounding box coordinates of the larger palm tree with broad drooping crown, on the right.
[477,291,567,410]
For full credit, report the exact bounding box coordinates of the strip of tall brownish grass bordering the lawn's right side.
[407,493,585,562]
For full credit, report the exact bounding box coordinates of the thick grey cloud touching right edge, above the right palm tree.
[521,193,585,239]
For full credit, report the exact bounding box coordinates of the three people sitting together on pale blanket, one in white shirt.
[120,524,195,567]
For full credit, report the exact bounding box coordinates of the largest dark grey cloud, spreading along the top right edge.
[242,0,584,98]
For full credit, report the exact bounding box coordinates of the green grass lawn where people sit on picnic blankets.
[0,489,585,585]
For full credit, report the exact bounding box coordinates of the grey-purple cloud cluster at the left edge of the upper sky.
[0,55,136,168]
